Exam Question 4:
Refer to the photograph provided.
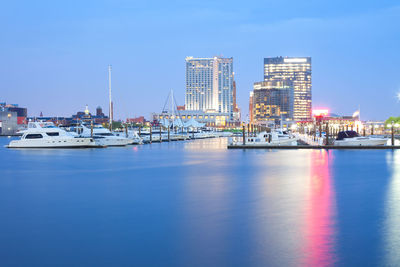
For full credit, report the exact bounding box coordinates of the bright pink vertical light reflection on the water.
[304,150,336,266]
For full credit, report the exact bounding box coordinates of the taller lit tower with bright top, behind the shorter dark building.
[264,57,312,121]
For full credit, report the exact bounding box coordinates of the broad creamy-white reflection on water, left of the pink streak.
[247,150,311,266]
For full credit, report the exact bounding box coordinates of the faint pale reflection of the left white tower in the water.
[177,142,234,266]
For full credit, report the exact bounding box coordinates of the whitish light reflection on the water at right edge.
[382,150,400,266]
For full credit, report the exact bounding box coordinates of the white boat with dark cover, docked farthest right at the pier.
[334,131,388,146]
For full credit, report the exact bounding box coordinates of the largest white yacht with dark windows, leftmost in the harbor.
[7,122,97,148]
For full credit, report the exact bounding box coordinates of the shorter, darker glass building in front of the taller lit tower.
[251,81,294,122]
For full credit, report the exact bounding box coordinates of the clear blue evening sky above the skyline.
[0,0,400,119]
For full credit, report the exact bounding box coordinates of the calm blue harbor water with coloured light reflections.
[0,138,400,266]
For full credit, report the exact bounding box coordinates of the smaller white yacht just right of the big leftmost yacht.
[80,124,132,146]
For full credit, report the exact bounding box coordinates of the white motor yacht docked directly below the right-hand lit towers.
[231,131,297,146]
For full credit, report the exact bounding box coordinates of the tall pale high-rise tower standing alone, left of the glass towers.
[185,57,233,118]
